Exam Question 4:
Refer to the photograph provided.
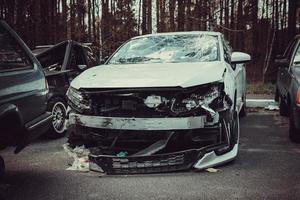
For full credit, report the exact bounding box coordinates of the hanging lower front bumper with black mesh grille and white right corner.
[89,144,238,174]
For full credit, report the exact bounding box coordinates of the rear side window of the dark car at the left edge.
[0,25,32,71]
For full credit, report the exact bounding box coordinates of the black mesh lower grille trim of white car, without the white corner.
[89,144,229,174]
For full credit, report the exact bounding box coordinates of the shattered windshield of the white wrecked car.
[108,34,219,64]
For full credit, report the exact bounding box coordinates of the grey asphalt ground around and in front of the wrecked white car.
[0,109,300,200]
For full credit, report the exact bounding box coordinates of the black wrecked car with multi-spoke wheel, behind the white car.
[33,40,100,138]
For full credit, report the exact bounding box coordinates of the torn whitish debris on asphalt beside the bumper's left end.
[63,143,90,172]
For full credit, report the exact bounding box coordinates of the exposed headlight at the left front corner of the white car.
[67,87,91,113]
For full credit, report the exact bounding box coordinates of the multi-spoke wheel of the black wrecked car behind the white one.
[46,97,67,139]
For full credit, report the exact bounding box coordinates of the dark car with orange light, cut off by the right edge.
[275,35,300,142]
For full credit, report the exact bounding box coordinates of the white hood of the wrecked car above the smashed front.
[71,61,226,89]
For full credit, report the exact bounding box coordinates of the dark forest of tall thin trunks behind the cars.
[0,0,300,82]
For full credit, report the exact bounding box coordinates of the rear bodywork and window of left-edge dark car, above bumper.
[0,21,47,123]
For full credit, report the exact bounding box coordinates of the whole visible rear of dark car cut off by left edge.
[0,21,52,175]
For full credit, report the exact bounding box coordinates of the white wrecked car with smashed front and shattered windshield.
[67,32,250,174]
